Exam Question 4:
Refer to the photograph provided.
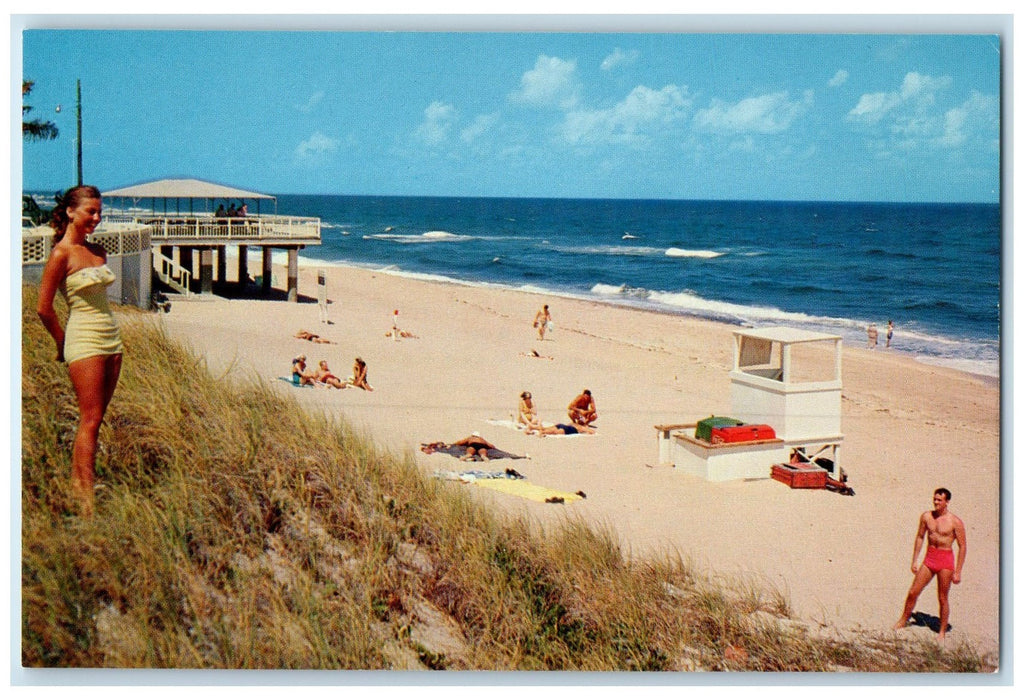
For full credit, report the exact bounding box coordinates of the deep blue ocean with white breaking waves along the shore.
[278,195,1001,377]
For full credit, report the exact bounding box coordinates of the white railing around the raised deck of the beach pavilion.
[104,213,321,243]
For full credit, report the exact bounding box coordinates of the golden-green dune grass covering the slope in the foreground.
[22,287,992,671]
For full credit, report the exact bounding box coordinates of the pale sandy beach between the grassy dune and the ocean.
[151,261,1000,651]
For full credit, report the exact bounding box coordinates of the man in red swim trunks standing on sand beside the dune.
[893,488,967,642]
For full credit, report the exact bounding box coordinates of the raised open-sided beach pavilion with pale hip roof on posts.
[102,178,321,301]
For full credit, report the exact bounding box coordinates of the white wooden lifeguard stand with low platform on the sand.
[654,327,843,481]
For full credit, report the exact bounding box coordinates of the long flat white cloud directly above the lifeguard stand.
[693,90,814,134]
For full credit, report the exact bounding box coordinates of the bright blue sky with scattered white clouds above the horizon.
[15,25,1000,202]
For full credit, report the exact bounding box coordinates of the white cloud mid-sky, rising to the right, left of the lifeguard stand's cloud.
[563,85,692,144]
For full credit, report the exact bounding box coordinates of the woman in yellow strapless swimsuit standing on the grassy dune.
[37,185,124,517]
